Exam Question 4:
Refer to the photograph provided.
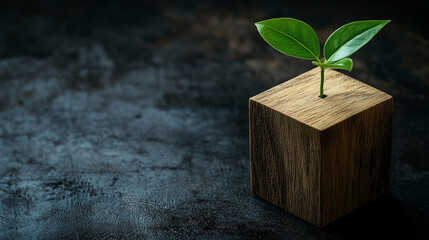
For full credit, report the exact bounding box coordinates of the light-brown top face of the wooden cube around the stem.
[250,68,392,130]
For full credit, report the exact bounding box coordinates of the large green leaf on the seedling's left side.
[255,18,320,59]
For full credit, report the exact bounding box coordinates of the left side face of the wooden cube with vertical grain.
[249,100,321,225]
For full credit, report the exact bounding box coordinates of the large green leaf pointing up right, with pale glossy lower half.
[323,20,390,63]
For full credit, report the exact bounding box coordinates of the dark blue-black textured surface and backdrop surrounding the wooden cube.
[0,1,429,240]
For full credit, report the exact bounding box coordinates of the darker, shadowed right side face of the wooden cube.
[321,98,393,226]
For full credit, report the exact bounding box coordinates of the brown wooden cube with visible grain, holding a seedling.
[249,68,393,227]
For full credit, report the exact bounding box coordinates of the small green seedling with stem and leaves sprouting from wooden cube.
[255,18,390,98]
